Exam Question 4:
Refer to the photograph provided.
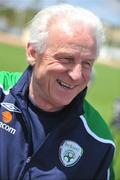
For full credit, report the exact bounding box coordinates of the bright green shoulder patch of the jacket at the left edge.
[0,71,21,92]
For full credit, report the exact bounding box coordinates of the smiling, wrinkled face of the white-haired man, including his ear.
[28,21,96,111]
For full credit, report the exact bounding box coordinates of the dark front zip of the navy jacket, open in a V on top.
[11,87,83,180]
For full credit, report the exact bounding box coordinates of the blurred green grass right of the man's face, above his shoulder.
[87,64,120,122]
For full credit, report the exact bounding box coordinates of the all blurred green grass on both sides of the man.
[0,44,120,180]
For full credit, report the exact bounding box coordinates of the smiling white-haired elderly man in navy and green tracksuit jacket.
[0,4,115,180]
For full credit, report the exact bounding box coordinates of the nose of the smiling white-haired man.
[68,64,82,81]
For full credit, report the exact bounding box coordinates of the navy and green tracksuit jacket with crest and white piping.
[0,67,115,180]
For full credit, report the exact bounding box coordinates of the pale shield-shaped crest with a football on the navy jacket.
[59,140,83,167]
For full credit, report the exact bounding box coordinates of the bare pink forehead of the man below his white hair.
[49,20,95,57]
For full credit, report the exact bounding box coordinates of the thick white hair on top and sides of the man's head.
[28,4,104,55]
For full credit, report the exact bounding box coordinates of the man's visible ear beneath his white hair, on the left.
[26,43,36,66]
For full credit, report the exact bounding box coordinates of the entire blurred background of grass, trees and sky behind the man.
[0,0,120,180]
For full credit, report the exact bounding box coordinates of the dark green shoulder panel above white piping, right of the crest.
[83,100,113,141]
